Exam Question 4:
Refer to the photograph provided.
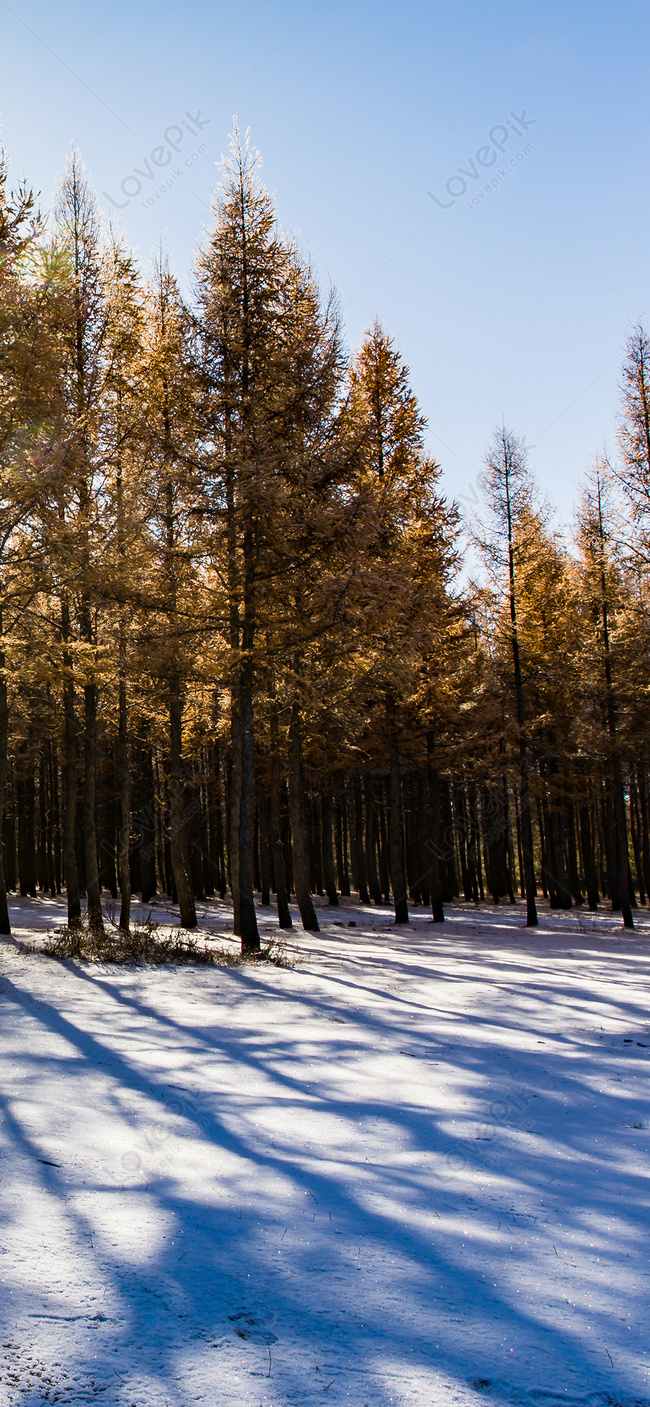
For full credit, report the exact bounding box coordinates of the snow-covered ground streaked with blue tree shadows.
[0,900,650,1407]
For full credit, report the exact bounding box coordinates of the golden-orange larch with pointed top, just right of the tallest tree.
[348,322,457,923]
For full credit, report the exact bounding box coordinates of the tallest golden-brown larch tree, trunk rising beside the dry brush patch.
[197,132,347,951]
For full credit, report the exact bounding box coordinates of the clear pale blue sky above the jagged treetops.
[0,0,650,518]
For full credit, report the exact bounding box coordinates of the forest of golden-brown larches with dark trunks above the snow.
[0,134,650,954]
